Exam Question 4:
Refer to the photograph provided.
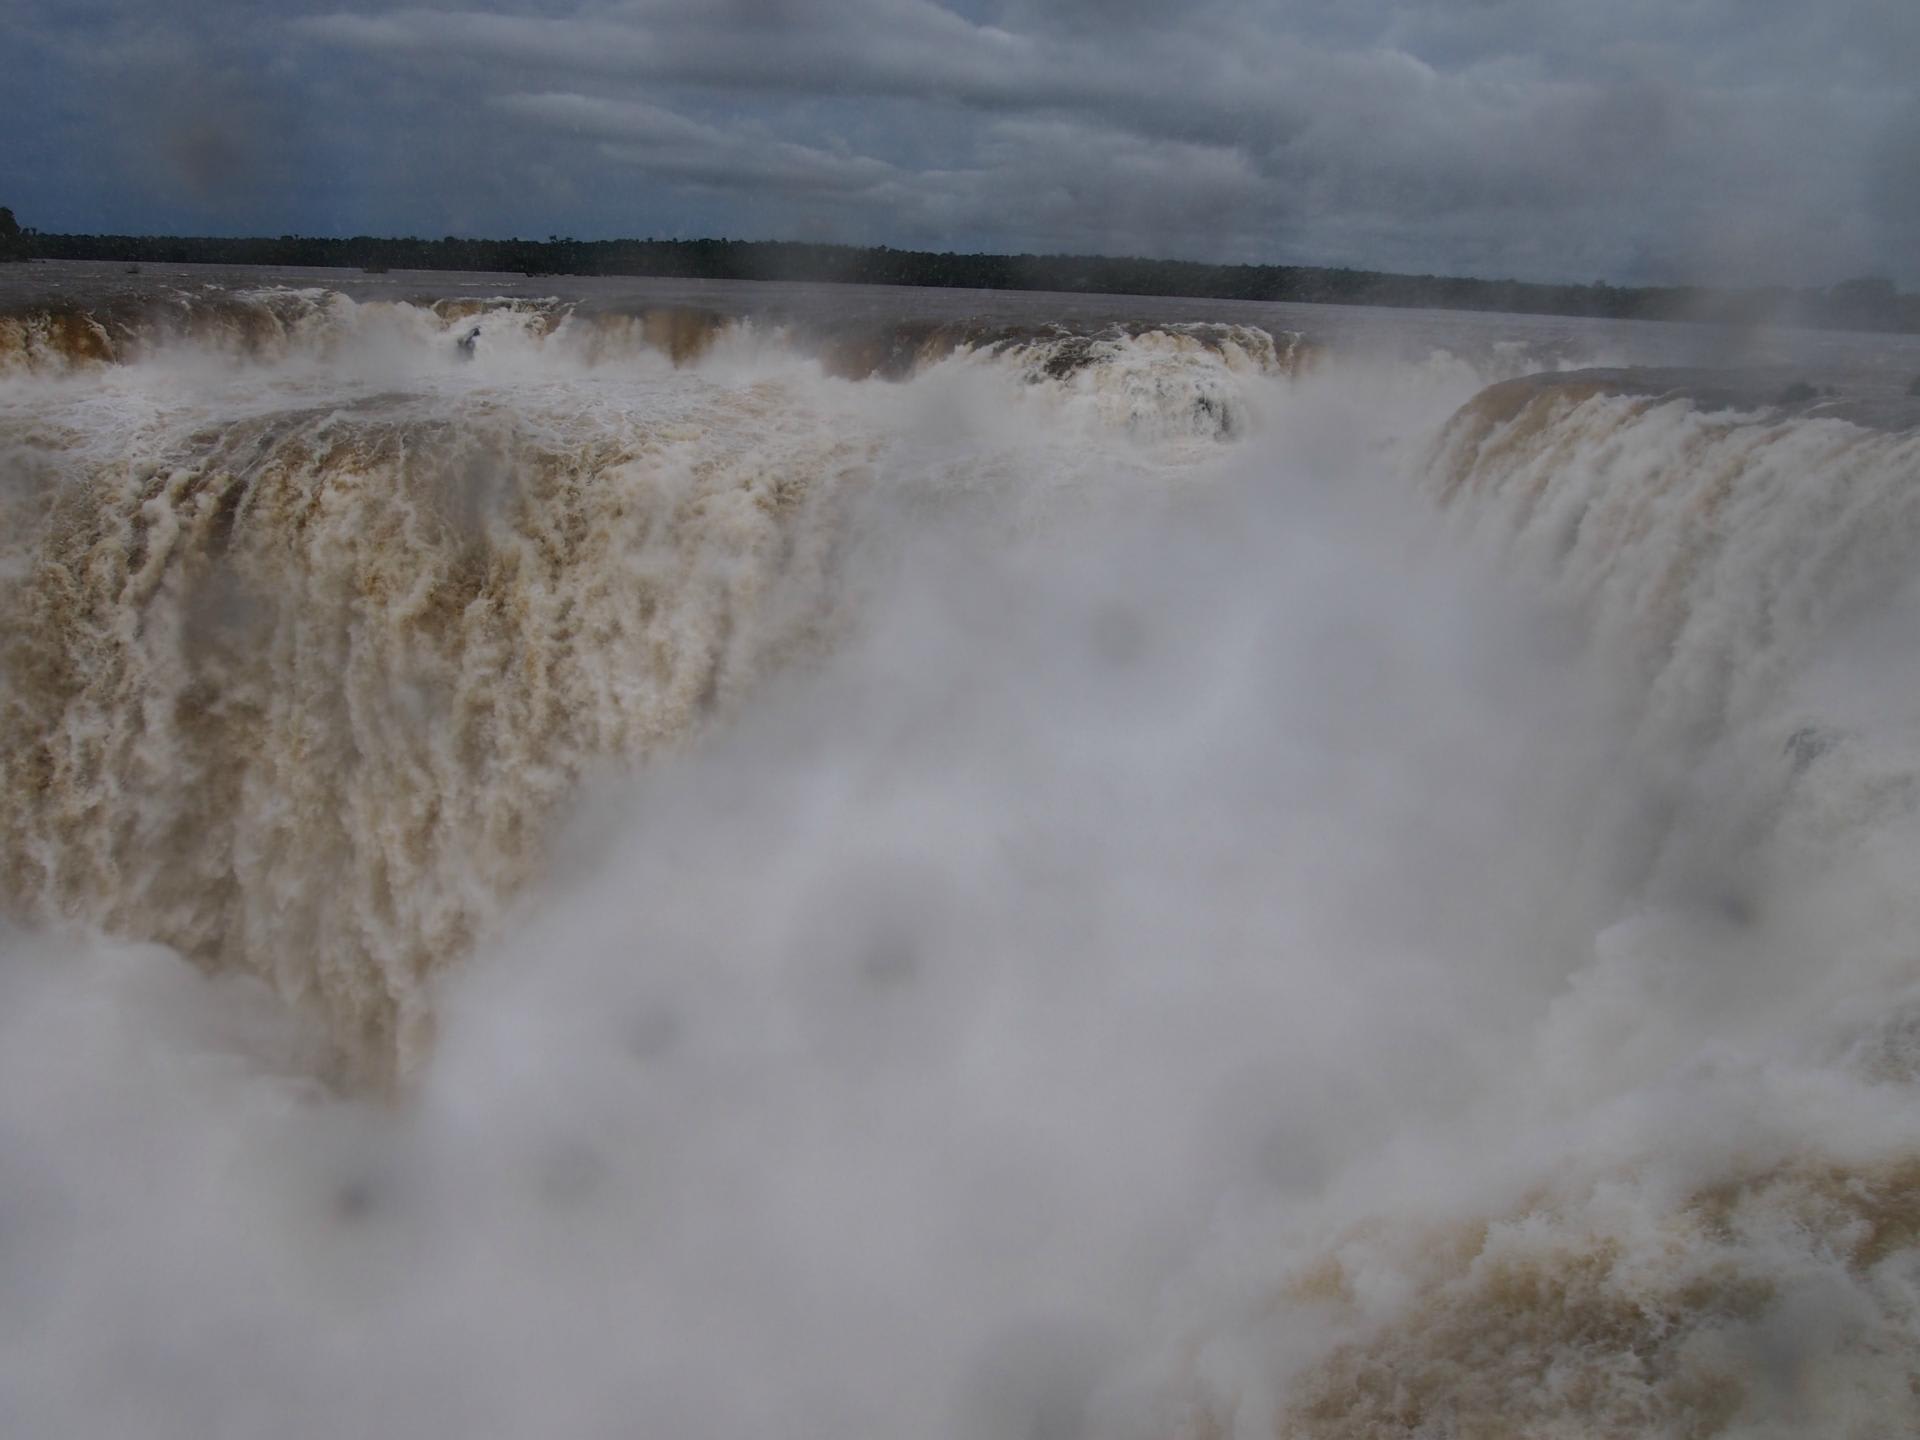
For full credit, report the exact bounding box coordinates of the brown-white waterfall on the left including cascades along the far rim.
[0,294,1292,1071]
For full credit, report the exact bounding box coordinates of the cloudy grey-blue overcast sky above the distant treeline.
[11,0,1920,288]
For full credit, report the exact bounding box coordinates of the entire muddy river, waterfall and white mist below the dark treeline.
[0,267,1920,1440]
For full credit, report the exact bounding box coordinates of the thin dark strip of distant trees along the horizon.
[21,230,1920,332]
